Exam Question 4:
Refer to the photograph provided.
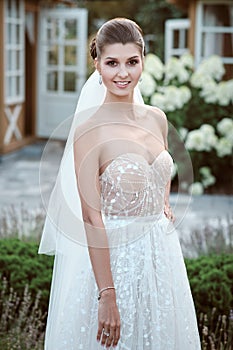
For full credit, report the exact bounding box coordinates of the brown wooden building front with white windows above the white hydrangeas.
[165,0,233,79]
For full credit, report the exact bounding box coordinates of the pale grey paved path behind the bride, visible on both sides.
[0,141,233,235]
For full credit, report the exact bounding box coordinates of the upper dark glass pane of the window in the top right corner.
[203,4,233,27]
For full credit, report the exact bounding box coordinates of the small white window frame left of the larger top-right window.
[164,19,190,62]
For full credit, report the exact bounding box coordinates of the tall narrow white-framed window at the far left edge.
[4,0,25,105]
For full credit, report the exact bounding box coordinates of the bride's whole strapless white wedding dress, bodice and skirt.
[45,150,201,350]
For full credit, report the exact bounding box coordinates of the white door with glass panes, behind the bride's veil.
[37,9,87,139]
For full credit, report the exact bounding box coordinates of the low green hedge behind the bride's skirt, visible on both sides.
[0,239,233,312]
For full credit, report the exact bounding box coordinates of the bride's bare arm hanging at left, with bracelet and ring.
[74,128,120,347]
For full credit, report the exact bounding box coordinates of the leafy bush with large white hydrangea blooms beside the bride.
[140,53,233,194]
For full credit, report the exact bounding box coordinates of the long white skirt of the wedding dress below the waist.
[45,214,201,350]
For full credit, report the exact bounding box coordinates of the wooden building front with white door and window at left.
[0,0,87,154]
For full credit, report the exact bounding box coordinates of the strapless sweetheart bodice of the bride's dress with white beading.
[100,150,173,218]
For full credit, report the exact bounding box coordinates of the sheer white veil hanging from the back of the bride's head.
[39,71,144,257]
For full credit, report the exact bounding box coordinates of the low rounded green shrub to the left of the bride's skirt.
[0,238,53,310]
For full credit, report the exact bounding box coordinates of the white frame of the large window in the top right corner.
[195,0,233,66]
